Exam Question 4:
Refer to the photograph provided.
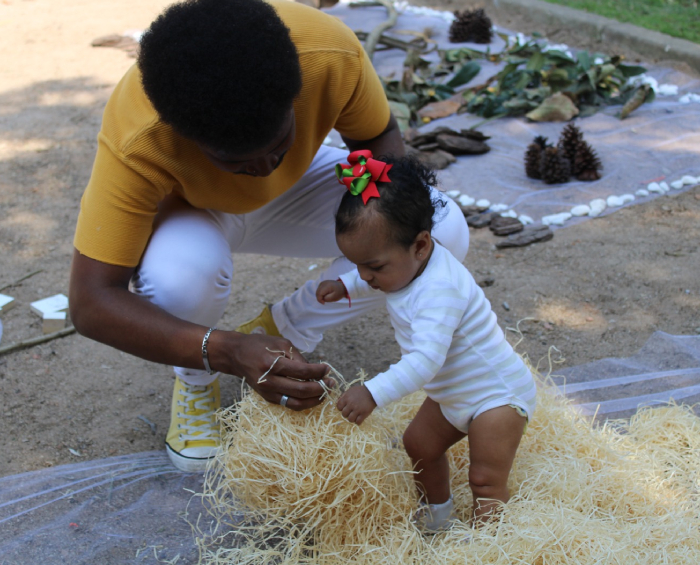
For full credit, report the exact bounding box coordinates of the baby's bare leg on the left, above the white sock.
[403,398,466,504]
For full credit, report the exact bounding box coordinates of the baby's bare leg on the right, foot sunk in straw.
[468,406,527,523]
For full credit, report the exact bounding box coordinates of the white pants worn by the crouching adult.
[131,146,469,385]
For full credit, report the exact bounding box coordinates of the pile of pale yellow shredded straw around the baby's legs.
[198,370,700,565]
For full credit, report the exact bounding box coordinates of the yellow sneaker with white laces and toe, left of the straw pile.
[165,377,221,473]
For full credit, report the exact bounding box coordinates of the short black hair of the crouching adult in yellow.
[138,0,301,154]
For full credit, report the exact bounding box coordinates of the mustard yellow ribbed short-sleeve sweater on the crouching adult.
[74,0,389,267]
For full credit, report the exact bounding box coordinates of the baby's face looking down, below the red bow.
[337,215,426,292]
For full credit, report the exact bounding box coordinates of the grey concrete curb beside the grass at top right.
[492,0,700,73]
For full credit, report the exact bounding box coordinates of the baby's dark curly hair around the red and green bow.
[335,155,447,248]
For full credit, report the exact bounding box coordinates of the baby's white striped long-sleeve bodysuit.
[340,241,536,433]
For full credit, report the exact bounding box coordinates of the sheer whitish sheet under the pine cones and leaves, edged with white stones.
[328,3,700,228]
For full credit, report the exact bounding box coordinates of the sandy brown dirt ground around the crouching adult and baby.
[0,0,700,476]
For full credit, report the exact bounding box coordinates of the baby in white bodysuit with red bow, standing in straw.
[316,151,536,532]
